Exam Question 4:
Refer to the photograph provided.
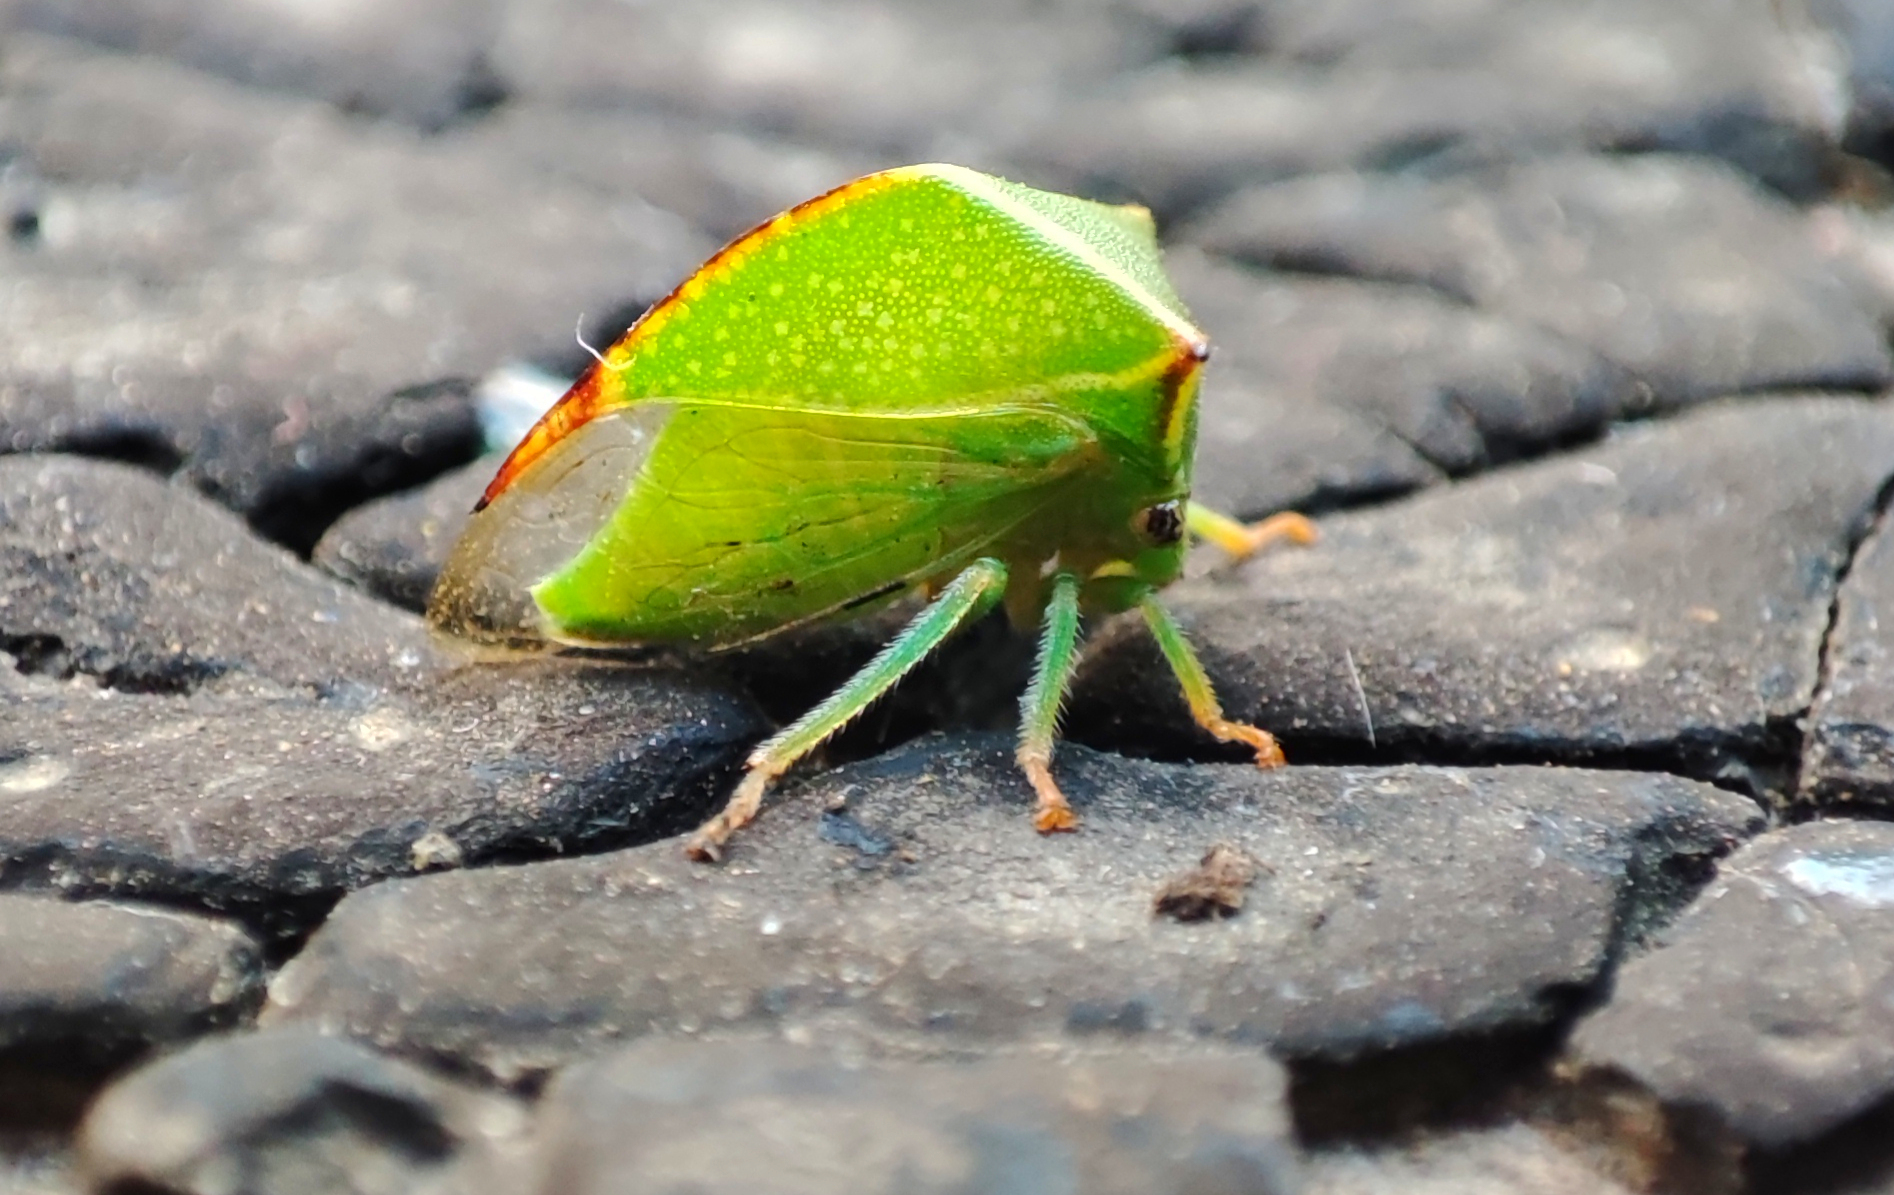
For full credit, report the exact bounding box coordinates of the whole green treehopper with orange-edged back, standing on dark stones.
[428,165,1313,860]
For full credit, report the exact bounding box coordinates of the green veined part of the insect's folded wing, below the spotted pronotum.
[532,403,1099,644]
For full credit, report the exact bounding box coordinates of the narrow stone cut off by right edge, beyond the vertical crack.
[1799,521,1894,805]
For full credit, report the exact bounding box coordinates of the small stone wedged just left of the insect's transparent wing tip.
[311,456,500,610]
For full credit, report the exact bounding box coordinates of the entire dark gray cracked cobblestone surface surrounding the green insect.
[0,0,1894,1195]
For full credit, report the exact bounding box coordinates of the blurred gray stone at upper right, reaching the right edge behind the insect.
[1184,155,1894,407]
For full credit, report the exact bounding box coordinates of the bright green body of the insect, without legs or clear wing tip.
[429,167,1203,644]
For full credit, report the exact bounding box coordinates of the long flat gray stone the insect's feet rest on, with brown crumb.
[265,737,1756,1078]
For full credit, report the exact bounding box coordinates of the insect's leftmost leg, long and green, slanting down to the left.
[684,559,1006,862]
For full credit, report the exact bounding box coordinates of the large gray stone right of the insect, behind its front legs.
[1068,400,1894,790]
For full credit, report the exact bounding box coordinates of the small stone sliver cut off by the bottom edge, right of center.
[1303,1125,1633,1195]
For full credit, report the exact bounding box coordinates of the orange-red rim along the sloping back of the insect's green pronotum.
[474,167,915,513]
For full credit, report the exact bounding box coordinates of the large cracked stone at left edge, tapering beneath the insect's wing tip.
[0,458,763,928]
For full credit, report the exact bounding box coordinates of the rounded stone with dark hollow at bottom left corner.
[78,1032,527,1195]
